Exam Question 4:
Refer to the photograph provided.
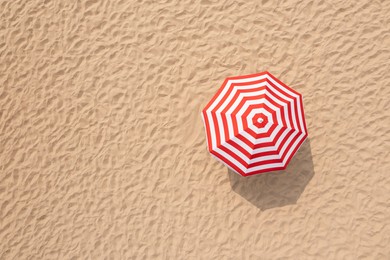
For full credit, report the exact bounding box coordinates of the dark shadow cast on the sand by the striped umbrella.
[228,139,314,210]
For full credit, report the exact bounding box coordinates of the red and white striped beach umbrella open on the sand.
[202,72,307,176]
